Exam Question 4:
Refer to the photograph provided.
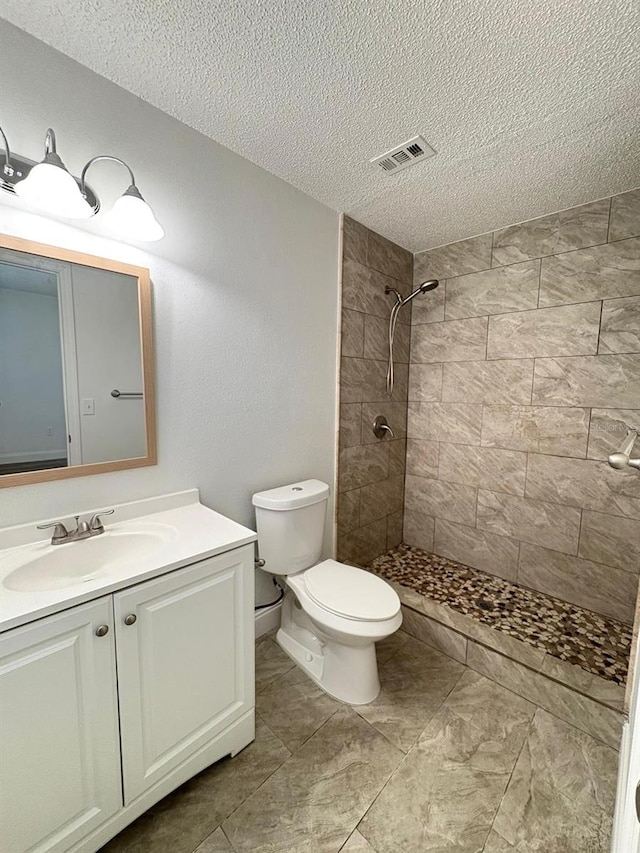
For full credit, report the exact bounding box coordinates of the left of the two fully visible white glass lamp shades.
[15,154,94,219]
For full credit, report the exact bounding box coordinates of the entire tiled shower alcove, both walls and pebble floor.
[337,190,640,740]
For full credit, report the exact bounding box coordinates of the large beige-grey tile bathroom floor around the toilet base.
[102,631,618,853]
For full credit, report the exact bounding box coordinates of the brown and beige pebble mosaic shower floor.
[369,545,632,684]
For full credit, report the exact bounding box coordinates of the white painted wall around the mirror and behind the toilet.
[0,22,338,551]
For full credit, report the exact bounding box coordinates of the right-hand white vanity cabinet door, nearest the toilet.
[114,546,254,804]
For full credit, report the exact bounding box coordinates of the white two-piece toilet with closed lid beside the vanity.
[253,480,402,705]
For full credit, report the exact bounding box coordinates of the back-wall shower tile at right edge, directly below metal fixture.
[526,453,640,519]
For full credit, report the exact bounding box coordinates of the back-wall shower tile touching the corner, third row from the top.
[411,317,487,363]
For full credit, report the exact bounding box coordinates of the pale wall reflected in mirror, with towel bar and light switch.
[71,264,146,464]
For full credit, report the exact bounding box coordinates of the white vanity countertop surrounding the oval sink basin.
[0,489,258,631]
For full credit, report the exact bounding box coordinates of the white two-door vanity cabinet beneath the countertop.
[0,545,254,853]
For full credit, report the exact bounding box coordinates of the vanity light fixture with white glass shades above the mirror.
[0,128,164,243]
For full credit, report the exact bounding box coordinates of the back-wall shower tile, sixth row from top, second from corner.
[438,444,527,496]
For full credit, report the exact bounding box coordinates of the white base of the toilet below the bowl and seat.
[276,593,380,705]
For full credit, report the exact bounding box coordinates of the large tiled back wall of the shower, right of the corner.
[404,190,640,622]
